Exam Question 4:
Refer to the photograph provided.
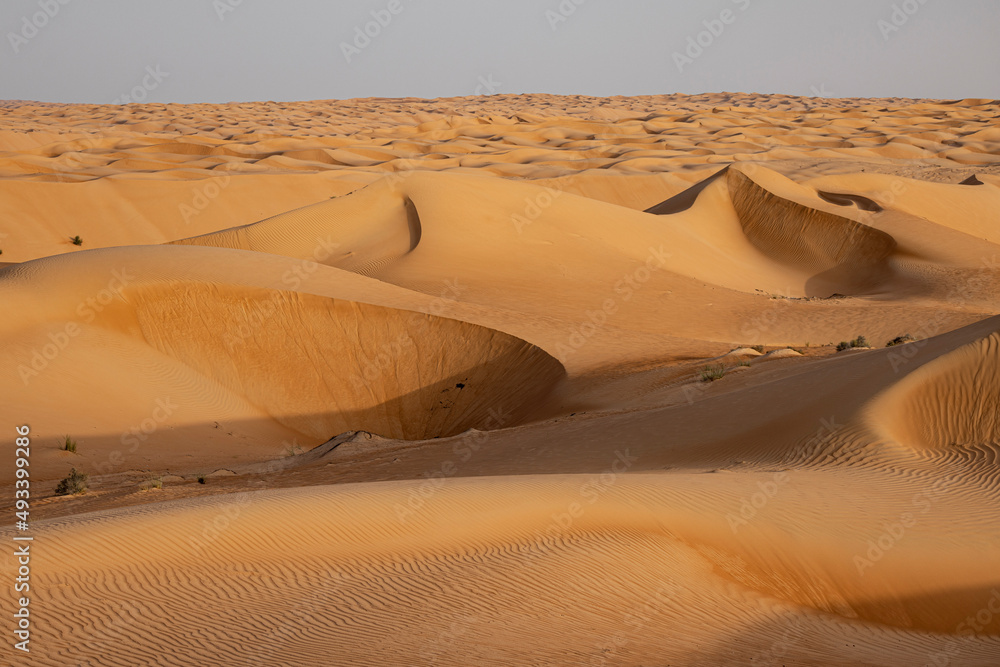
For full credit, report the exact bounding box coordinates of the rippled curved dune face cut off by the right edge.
[869,333,1000,458]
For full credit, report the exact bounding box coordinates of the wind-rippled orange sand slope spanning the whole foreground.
[11,319,1000,665]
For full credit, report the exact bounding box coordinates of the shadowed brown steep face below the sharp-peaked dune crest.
[727,169,896,296]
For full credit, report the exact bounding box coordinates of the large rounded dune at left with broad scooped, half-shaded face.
[0,246,564,479]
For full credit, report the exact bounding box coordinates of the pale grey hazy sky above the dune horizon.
[0,0,1000,103]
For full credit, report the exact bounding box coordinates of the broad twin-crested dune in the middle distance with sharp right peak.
[164,165,1000,374]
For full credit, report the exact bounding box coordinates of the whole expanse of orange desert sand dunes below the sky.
[0,94,1000,667]
